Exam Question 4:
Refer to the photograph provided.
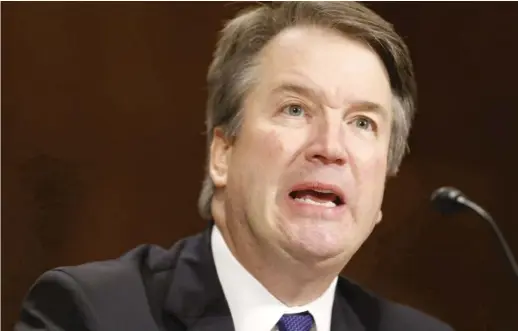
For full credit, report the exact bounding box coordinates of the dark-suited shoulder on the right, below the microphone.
[337,277,453,331]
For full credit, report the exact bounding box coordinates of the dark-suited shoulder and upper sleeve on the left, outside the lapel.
[15,239,194,331]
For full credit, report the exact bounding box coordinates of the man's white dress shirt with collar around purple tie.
[212,226,337,331]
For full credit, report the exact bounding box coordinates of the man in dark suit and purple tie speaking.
[16,2,451,331]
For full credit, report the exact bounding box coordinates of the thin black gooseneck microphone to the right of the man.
[431,186,518,277]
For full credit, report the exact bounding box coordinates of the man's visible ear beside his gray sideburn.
[209,128,232,187]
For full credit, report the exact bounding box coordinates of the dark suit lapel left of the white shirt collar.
[164,224,234,331]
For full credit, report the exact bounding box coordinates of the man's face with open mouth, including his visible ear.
[211,27,392,261]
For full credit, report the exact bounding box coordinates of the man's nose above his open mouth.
[306,121,347,165]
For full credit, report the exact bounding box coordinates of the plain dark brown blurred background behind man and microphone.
[1,2,518,331]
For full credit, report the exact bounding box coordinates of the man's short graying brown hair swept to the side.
[198,1,416,220]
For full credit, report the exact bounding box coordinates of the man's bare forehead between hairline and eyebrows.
[254,27,392,109]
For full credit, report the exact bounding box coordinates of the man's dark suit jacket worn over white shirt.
[15,227,452,331]
